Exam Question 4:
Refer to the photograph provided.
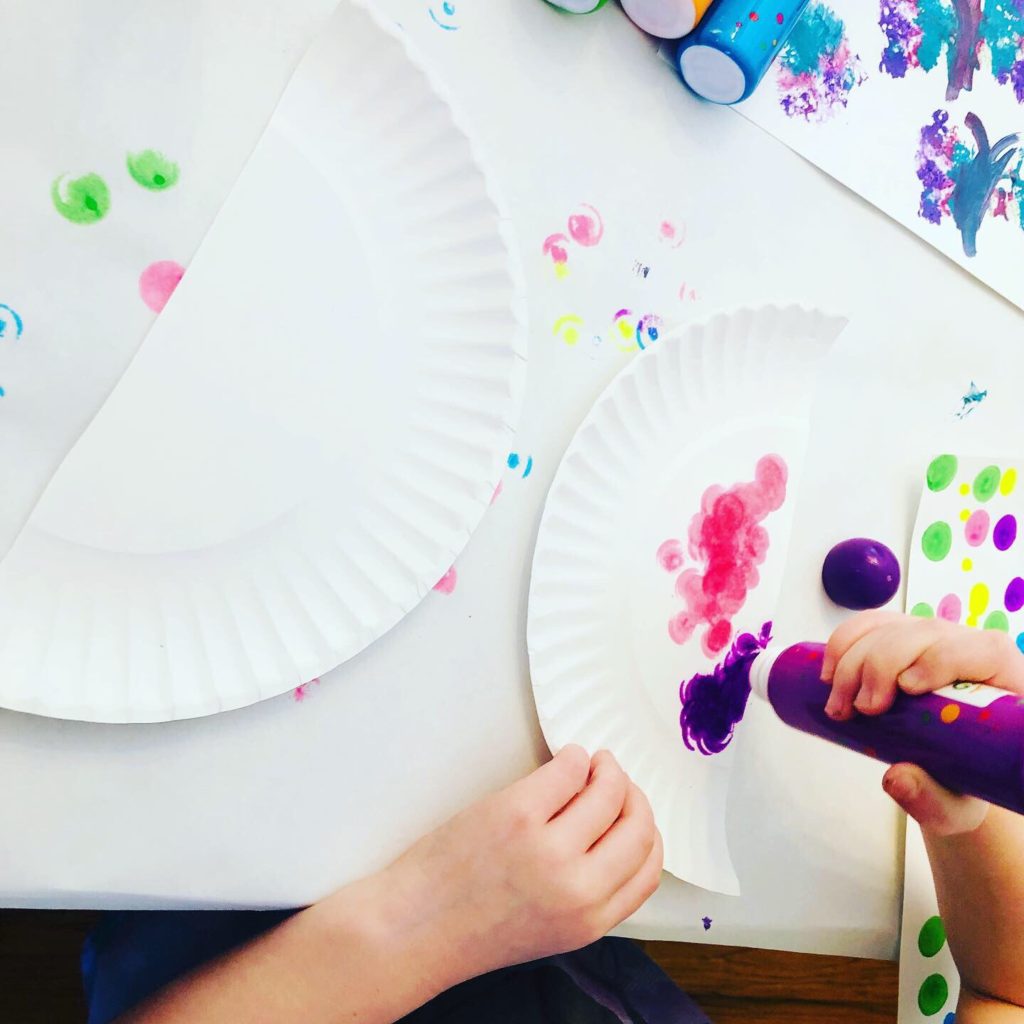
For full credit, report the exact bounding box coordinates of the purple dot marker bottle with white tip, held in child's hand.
[744,643,1024,814]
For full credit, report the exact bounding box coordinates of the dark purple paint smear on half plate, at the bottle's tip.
[679,623,771,755]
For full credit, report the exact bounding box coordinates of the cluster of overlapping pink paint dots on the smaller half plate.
[669,455,788,657]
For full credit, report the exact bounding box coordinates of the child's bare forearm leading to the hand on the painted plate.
[119,872,463,1024]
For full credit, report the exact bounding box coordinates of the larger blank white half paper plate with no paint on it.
[0,3,525,722]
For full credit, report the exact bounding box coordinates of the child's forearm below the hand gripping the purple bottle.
[925,807,1024,1007]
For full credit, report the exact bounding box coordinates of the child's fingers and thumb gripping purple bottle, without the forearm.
[821,611,1024,836]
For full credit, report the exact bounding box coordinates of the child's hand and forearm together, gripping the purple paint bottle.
[822,611,1024,1011]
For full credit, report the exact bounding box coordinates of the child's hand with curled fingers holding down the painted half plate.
[381,745,662,984]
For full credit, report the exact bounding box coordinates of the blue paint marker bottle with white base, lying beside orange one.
[676,0,808,103]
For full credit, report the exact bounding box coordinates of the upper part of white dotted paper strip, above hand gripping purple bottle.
[906,453,1024,651]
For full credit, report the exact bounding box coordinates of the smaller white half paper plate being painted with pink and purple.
[528,307,845,894]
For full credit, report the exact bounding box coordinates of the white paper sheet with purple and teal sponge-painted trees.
[738,0,1024,305]
